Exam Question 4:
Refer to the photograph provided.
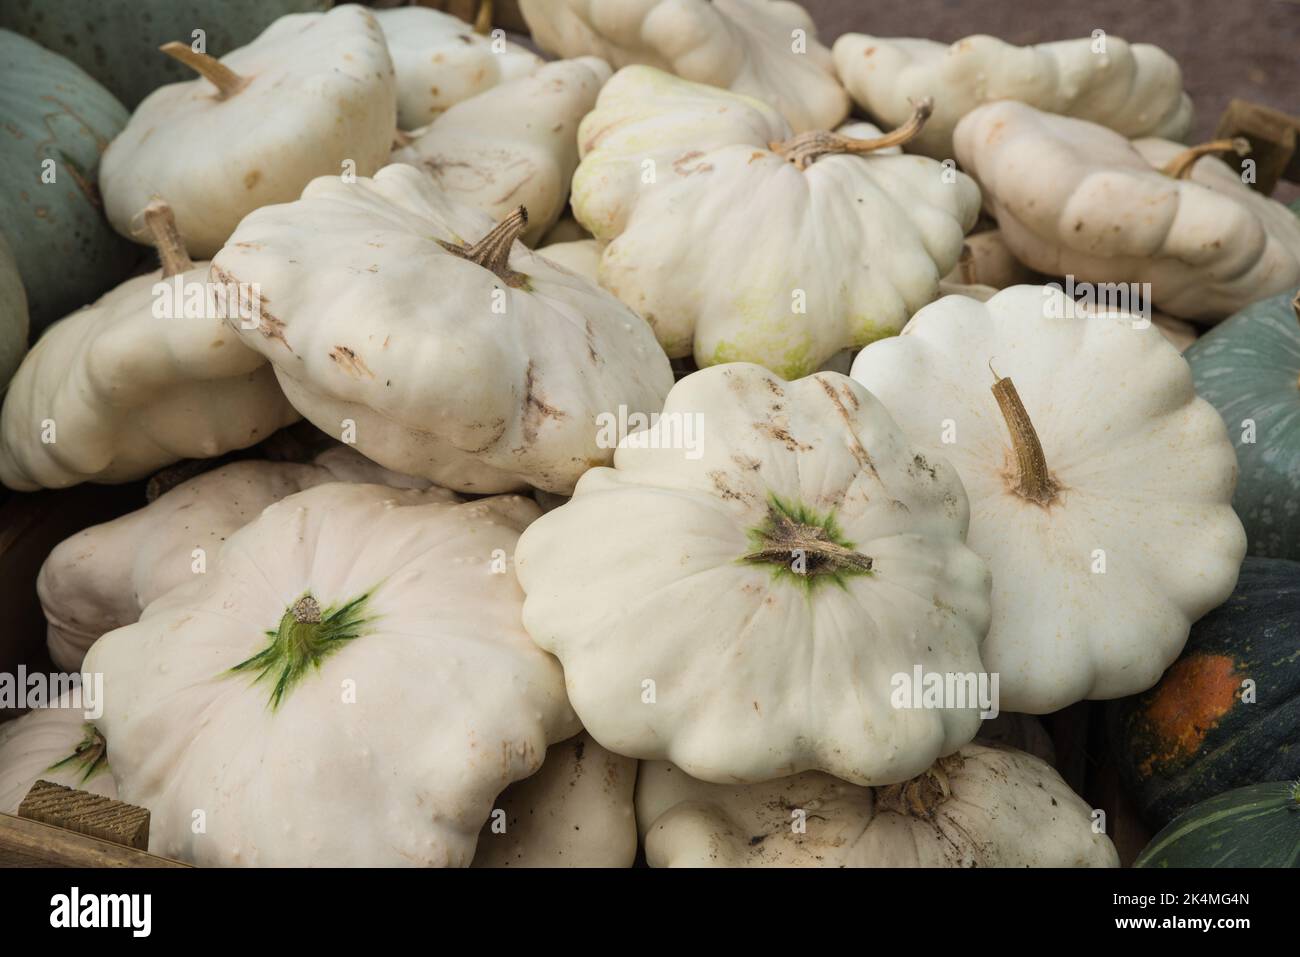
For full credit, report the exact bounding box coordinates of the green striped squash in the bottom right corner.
[1134,781,1300,867]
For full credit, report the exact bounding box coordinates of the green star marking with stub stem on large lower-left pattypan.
[226,593,372,711]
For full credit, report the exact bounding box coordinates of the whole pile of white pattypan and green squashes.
[0,0,1300,866]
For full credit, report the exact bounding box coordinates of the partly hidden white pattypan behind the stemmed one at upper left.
[374,7,542,130]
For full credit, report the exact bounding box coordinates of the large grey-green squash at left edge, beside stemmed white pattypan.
[0,30,140,334]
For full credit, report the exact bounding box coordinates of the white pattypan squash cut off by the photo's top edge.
[520,0,850,133]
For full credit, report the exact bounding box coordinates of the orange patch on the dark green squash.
[1139,654,1243,775]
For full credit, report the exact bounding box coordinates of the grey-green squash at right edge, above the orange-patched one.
[1183,293,1300,559]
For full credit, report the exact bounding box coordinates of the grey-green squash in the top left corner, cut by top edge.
[0,0,330,109]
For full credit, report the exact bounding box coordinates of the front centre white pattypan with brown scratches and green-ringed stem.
[516,363,989,784]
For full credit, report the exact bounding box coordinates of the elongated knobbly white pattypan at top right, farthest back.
[835,34,1192,160]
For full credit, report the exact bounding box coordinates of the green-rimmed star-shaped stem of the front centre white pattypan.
[740,493,874,592]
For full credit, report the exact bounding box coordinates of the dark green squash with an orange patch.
[1109,558,1300,827]
